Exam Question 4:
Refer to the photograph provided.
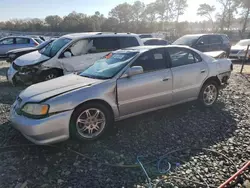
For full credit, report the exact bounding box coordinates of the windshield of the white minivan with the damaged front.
[40,38,71,57]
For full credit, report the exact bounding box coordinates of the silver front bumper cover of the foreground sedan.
[10,107,73,145]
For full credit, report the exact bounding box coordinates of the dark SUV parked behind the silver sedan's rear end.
[173,34,231,56]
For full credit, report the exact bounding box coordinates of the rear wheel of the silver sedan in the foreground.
[199,81,219,107]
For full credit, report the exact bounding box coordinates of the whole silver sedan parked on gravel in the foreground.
[10,46,232,144]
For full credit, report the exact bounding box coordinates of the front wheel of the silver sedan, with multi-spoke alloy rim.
[70,103,114,141]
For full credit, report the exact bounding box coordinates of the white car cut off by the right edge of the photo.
[229,39,250,59]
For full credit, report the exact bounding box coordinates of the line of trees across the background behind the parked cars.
[0,0,250,34]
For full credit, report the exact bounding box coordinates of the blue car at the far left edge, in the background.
[0,36,43,57]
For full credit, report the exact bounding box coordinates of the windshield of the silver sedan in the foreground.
[80,51,138,79]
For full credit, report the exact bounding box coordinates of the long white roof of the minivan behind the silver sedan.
[62,32,137,39]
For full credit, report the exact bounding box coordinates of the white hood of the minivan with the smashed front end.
[15,51,50,66]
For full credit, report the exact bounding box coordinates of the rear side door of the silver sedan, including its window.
[168,48,208,103]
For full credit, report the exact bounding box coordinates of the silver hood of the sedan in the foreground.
[19,74,104,102]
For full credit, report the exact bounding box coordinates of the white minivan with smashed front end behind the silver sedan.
[7,32,143,85]
